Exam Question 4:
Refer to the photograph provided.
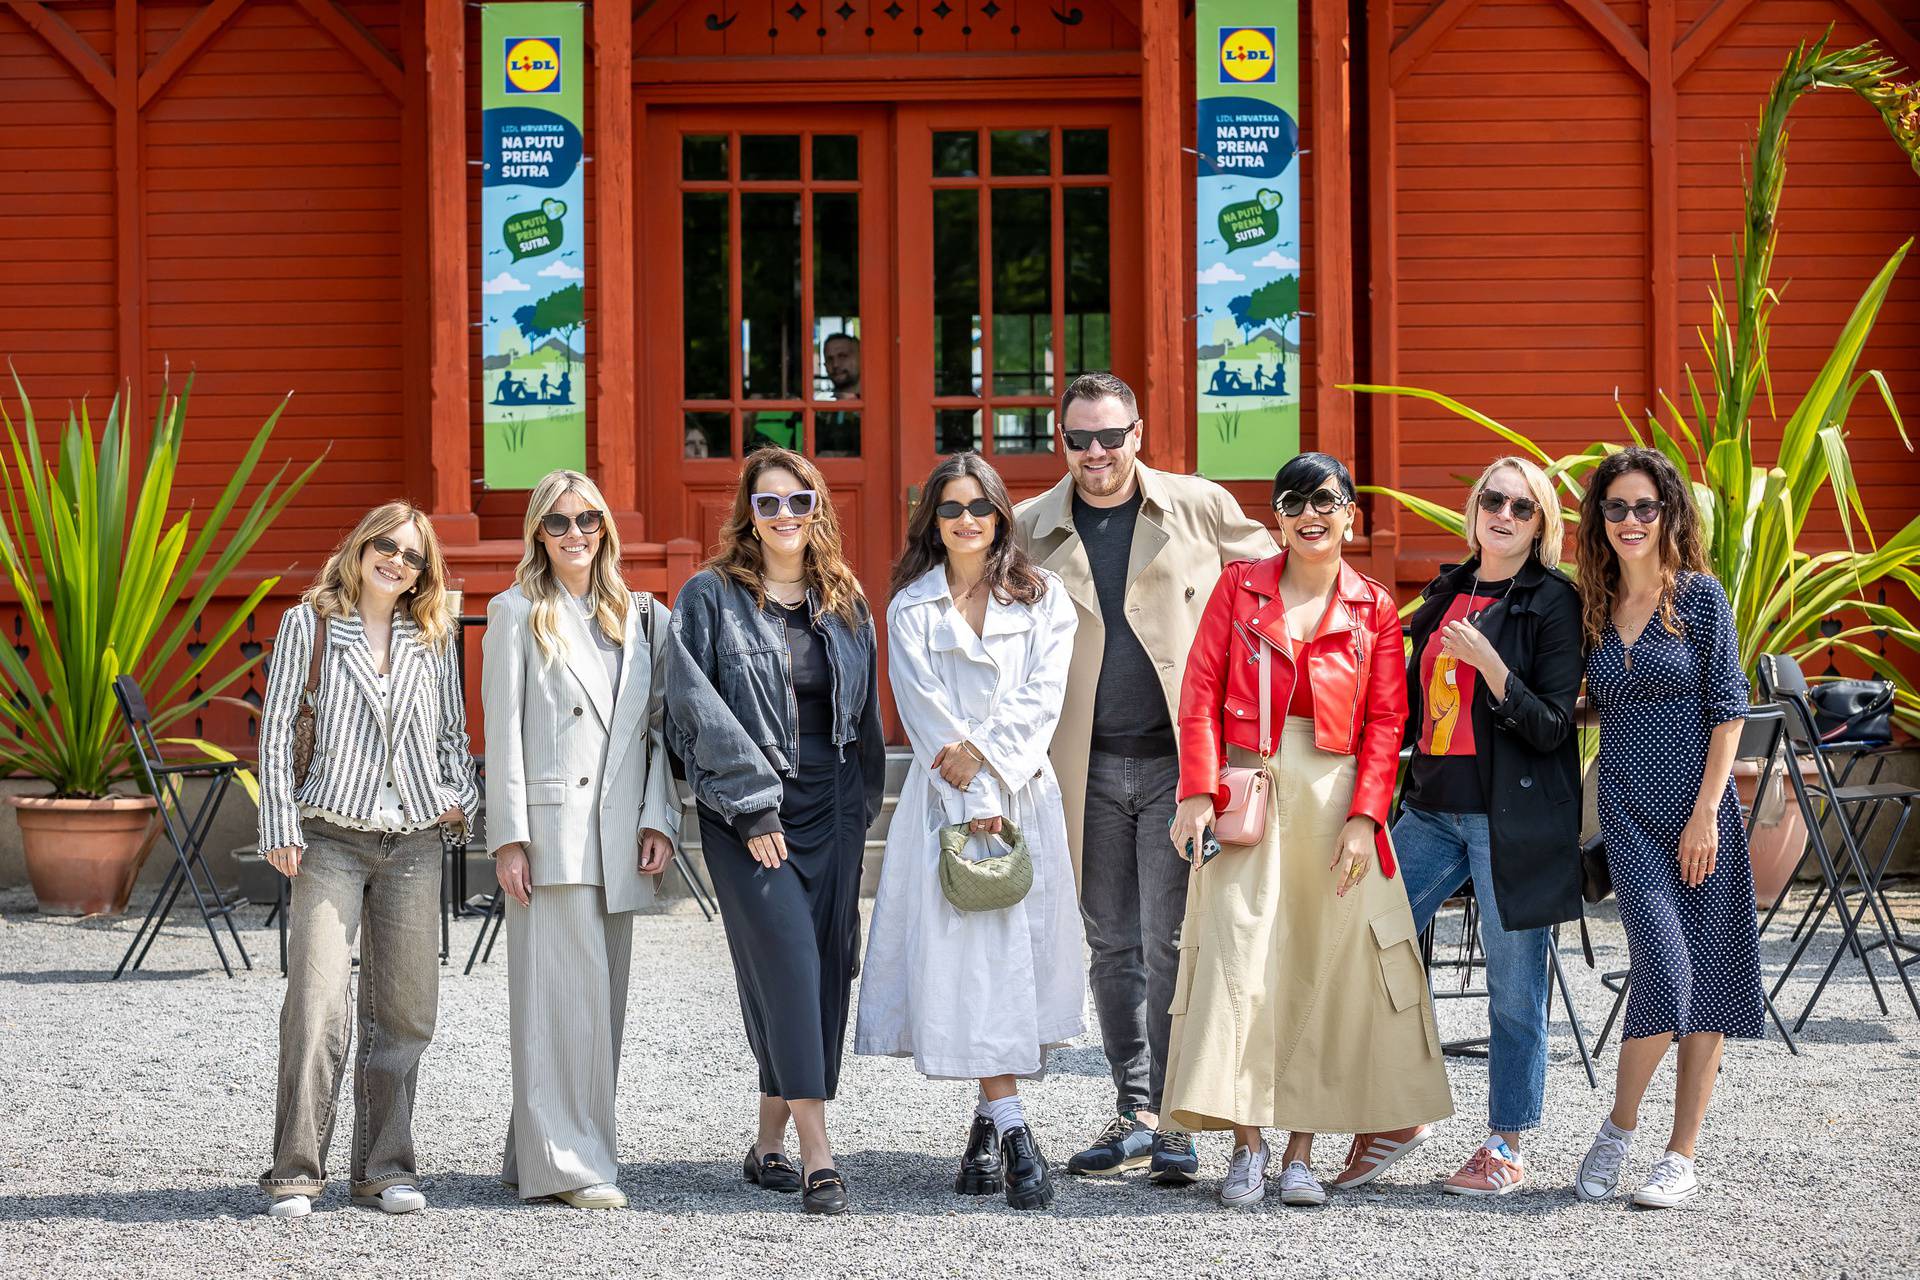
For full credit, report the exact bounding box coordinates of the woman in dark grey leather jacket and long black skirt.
[666,449,887,1213]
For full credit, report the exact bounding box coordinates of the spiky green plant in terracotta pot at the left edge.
[0,374,319,913]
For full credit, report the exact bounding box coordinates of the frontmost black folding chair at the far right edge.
[1759,652,1920,1031]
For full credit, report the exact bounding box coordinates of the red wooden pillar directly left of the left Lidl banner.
[424,0,480,543]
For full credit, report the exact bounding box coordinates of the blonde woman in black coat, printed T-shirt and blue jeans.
[1334,457,1582,1196]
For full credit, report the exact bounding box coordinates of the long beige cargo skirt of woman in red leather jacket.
[1165,718,1453,1134]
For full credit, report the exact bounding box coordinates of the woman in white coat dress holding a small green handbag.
[854,453,1087,1209]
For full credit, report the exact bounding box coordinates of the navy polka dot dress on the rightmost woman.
[1586,574,1766,1040]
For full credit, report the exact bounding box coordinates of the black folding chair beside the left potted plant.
[113,676,253,979]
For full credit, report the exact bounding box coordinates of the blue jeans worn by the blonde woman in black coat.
[1394,806,1548,1134]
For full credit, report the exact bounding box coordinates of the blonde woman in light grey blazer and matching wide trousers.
[480,470,680,1209]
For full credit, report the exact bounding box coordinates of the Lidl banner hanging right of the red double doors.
[1194,0,1300,480]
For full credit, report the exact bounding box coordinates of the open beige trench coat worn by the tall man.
[1014,462,1275,879]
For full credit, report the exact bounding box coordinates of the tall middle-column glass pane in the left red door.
[739,192,804,399]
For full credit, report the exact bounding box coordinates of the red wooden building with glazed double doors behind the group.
[0,0,1920,740]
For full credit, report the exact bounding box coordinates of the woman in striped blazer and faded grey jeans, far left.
[259,503,478,1217]
